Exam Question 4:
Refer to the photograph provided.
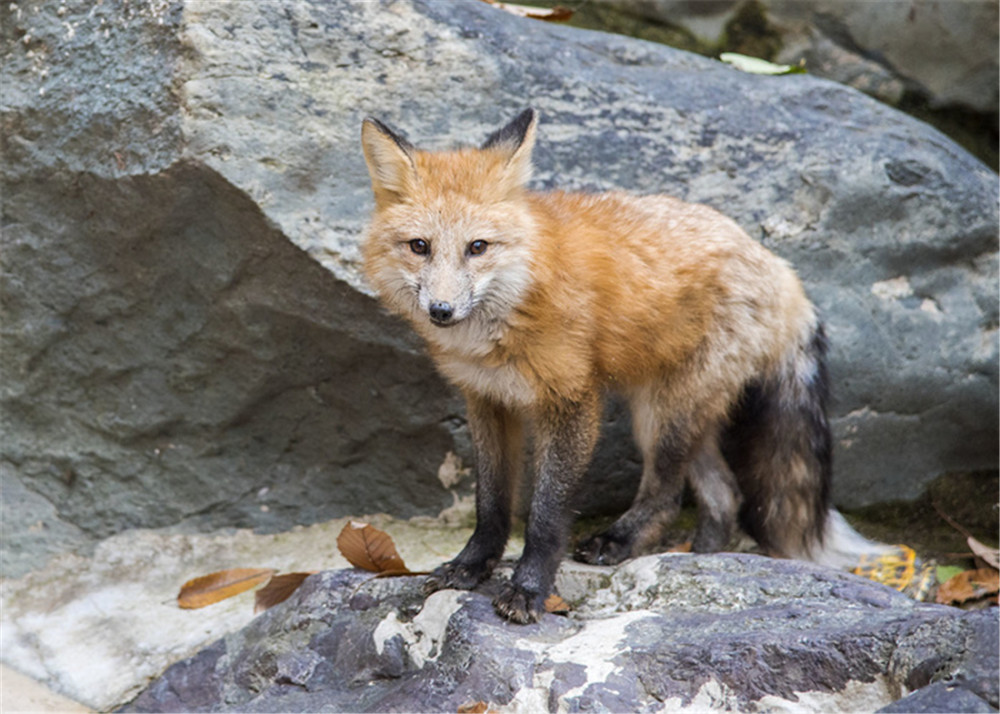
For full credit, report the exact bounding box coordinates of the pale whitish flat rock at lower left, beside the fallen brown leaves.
[0,515,492,711]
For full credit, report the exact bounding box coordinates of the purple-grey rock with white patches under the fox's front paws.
[125,555,998,712]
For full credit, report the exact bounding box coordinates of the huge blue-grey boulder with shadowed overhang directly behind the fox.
[0,0,998,575]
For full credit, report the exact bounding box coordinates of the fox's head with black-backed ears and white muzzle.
[361,109,537,344]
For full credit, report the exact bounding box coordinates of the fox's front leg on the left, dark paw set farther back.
[424,394,523,594]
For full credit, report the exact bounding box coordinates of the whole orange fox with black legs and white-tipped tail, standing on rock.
[362,109,874,623]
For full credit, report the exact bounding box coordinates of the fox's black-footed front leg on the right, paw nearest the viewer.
[493,398,601,624]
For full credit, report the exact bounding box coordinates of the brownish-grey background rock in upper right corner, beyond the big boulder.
[598,0,1000,116]
